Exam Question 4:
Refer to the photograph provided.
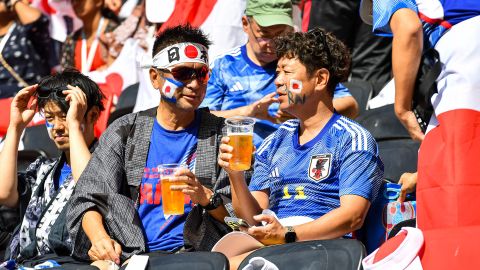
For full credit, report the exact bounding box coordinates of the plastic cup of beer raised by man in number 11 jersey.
[225,116,255,171]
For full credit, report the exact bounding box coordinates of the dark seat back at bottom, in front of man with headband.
[120,252,233,270]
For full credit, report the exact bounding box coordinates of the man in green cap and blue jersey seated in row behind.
[202,0,358,147]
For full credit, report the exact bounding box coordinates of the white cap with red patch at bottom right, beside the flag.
[362,227,423,270]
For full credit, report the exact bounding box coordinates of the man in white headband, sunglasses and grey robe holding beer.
[69,26,237,264]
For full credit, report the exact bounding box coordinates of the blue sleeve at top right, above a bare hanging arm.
[373,0,418,36]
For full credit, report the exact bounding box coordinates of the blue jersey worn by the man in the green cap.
[201,45,351,147]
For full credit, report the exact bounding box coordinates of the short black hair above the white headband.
[152,24,212,57]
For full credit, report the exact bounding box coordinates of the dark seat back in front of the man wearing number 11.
[238,239,365,270]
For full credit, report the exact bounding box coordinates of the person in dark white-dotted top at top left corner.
[0,0,52,98]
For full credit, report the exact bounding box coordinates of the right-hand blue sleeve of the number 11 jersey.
[339,136,383,202]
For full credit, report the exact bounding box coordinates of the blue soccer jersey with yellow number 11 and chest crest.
[249,113,383,219]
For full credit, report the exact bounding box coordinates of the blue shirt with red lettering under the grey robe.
[138,112,200,251]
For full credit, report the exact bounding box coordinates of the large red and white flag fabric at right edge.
[417,16,480,269]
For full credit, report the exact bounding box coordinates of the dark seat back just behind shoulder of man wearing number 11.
[355,104,410,141]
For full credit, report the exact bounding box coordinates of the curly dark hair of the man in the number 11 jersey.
[274,27,351,95]
